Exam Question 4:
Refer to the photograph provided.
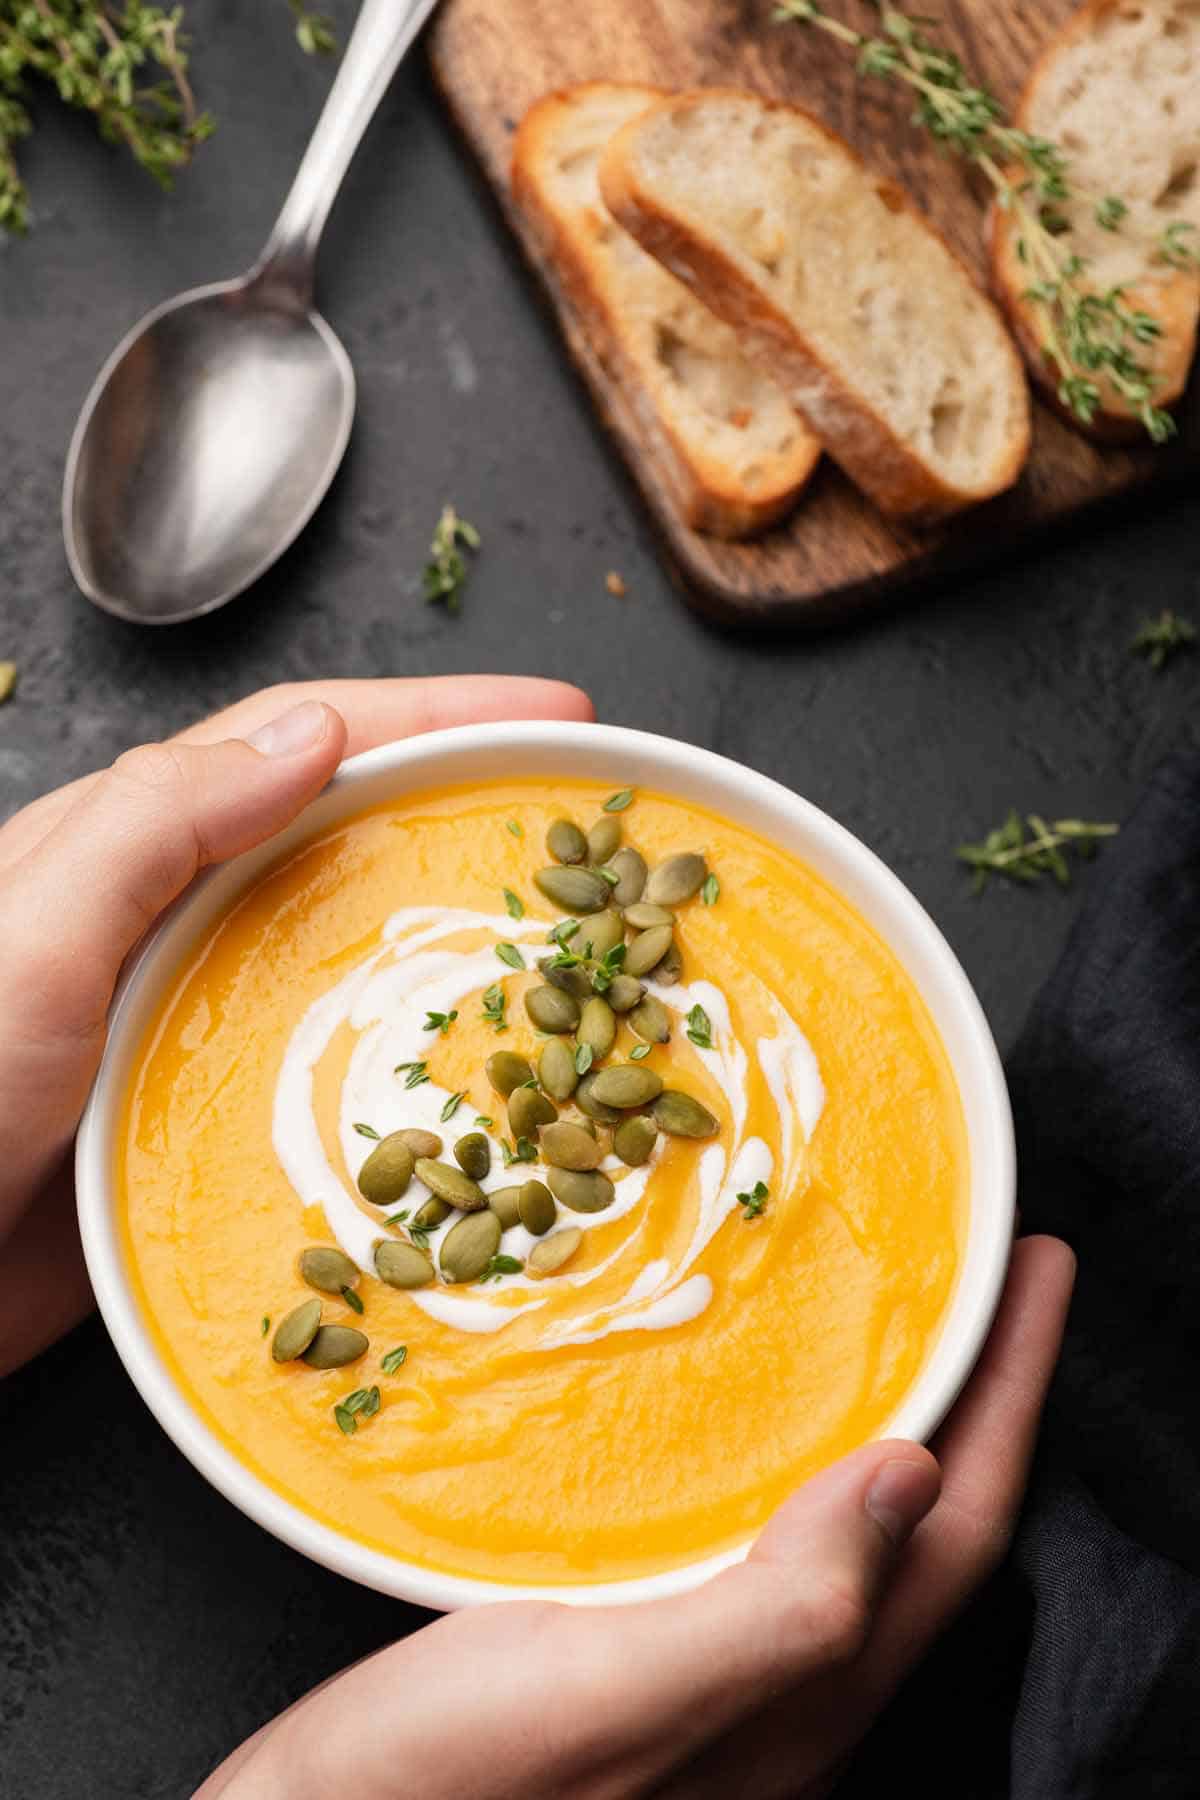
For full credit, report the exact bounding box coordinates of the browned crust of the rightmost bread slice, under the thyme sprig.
[984,0,1200,443]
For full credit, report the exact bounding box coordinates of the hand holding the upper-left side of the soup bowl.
[0,675,592,1375]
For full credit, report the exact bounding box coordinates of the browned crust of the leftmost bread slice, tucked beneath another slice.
[511,81,820,540]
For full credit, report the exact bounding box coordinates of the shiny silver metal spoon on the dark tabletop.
[63,0,435,625]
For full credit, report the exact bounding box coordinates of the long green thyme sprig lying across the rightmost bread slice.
[774,0,1200,443]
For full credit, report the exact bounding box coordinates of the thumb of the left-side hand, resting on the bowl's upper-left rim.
[0,700,345,1233]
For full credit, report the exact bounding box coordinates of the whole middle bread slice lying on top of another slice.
[601,88,1029,518]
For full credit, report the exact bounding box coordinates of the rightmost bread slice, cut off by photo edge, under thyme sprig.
[990,0,1200,437]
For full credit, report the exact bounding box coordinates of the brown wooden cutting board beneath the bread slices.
[430,0,1200,625]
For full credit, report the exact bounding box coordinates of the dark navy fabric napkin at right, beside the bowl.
[838,754,1200,1800]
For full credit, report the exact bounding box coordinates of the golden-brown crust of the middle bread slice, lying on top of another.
[599,86,1031,522]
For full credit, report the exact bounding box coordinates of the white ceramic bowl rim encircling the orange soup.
[77,722,1015,1609]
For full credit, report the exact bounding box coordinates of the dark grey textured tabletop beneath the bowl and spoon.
[0,0,1200,1800]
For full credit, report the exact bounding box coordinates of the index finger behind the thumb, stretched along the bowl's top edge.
[0,675,596,869]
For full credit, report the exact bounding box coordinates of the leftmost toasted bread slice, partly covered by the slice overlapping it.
[513,81,820,538]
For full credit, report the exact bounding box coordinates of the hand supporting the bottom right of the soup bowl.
[196,1238,1074,1800]
